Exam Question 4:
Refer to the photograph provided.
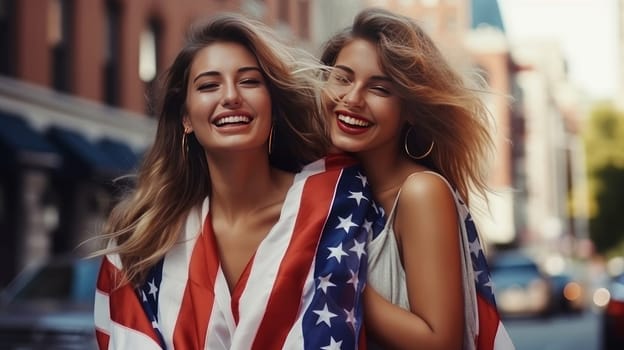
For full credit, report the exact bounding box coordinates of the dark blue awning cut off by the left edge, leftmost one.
[0,111,62,168]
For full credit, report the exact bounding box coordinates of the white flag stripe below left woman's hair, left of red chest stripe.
[157,198,208,349]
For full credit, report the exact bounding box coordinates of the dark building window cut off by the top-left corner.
[0,0,16,76]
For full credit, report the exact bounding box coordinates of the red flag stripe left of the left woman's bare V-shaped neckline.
[173,215,219,349]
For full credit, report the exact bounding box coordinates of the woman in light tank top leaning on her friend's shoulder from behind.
[321,9,513,350]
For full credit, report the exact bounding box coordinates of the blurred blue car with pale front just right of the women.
[490,250,553,317]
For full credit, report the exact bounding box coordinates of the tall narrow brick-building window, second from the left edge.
[48,0,72,92]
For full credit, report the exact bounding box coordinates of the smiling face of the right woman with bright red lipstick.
[327,39,403,157]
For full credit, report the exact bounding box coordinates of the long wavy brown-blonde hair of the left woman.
[93,13,330,286]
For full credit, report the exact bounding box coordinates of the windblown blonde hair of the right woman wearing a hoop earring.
[321,8,493,205]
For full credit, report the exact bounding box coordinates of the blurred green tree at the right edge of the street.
[584,103,624,253]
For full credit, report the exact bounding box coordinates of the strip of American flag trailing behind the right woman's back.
[454,191,515,350]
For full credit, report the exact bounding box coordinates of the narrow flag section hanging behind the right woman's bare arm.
[449,194,515,350]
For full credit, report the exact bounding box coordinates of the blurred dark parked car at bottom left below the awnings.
[0,257,101,350]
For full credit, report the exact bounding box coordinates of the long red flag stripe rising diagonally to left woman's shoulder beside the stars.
[252,163,344,350]
